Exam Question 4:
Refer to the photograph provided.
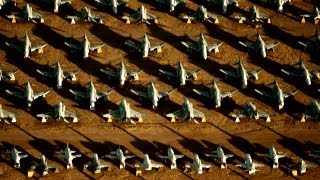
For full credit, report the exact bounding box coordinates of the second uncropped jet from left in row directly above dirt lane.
[102,99,143,124]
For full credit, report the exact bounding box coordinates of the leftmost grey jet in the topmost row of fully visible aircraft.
[6,3,44,23]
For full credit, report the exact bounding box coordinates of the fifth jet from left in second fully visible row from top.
[239,33,280,58]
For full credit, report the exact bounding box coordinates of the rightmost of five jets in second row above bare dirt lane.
[255,81,299,110]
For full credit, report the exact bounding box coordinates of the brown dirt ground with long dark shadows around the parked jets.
[0,0,320,179]
